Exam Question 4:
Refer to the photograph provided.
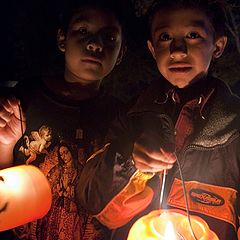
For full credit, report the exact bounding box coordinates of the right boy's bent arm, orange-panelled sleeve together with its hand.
[76,111,176,229]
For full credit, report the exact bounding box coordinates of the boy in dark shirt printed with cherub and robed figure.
[0,1,125,240]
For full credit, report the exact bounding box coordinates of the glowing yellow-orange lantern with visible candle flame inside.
[128,209,218,240]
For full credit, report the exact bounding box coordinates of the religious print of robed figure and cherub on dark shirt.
[14,125,105,240]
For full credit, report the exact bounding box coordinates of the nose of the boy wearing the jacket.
[170,40,187,59]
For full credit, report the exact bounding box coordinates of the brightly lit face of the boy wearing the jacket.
[148,8,227,88]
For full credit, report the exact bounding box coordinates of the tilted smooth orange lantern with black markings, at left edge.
[0,165,52,231]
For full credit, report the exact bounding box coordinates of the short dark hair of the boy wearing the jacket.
[147,0,226,39]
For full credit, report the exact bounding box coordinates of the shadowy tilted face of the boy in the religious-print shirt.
[58,7,122,84]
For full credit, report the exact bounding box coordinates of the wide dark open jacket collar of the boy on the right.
[128,77,240,147]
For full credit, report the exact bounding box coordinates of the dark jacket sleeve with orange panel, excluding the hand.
[76,135,156,229]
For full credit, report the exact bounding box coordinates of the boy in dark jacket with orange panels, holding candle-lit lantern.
[78,0,240,240]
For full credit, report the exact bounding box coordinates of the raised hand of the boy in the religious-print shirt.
[0,98,26,168]
